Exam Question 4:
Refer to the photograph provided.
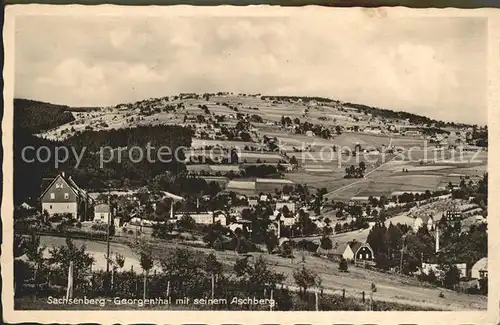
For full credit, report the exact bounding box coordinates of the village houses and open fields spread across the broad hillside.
[14,93,488,309]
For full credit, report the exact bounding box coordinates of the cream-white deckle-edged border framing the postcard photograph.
[1,4,500,324]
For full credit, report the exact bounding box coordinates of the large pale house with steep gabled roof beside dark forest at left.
[40,172,93,221]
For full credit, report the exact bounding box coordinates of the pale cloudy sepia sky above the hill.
[14,16,487,124]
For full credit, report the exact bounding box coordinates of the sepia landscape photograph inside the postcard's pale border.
[2,8,496,322]
